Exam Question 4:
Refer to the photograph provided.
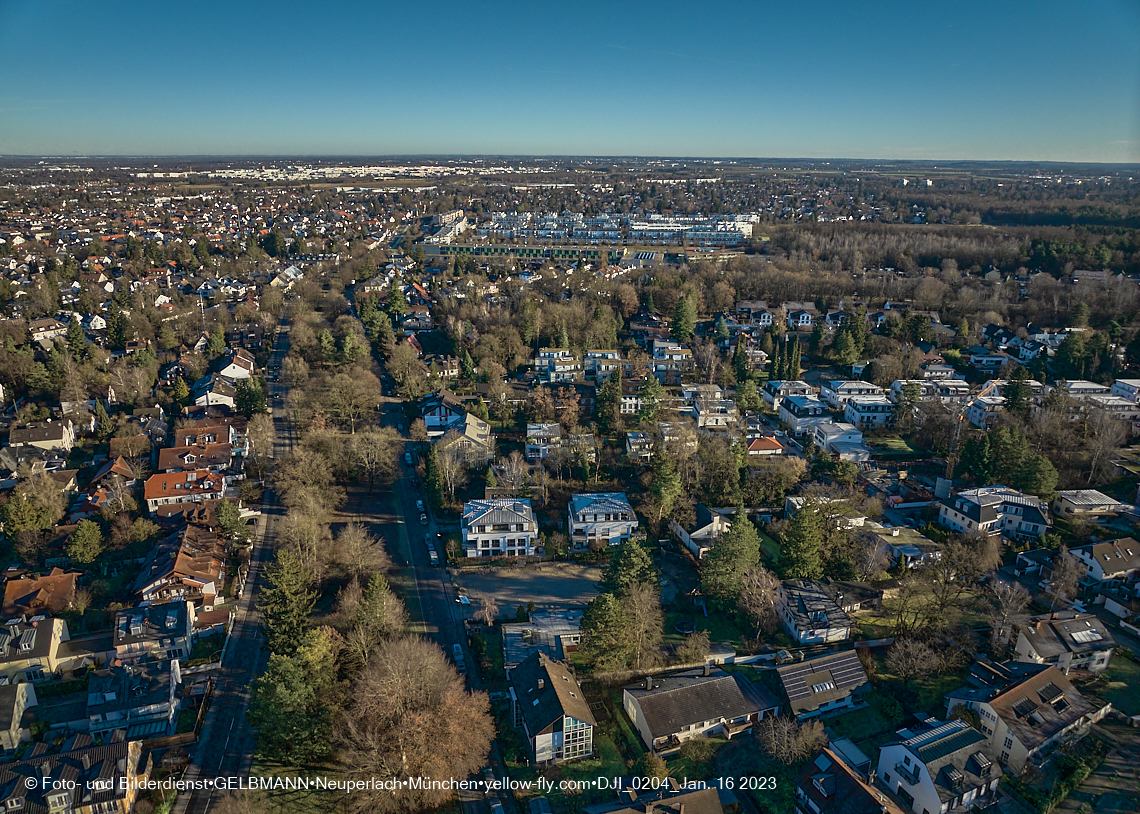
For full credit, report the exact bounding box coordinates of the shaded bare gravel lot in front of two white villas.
[455,562,602,617]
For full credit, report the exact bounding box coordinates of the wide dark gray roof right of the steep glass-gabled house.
[625,668,768,739]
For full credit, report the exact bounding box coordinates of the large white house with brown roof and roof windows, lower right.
[946,657,1113,774]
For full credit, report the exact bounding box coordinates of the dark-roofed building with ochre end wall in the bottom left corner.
[0,733,152,814]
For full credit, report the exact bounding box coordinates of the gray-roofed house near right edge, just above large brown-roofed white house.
[1015,611,1116,675]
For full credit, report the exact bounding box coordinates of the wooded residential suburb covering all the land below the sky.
[0,157,1140,814]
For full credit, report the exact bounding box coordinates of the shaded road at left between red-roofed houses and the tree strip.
[173,321,296,814]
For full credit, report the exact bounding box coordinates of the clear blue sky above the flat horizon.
[0,0,1140,162]
